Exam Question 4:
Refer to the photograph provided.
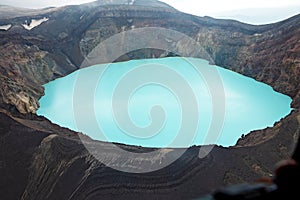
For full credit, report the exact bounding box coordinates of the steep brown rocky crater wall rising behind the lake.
[0,5,300,112]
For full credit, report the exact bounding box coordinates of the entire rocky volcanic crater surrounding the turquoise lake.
[0,0,300,199]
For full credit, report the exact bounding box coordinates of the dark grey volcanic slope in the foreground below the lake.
[0,111,300,200]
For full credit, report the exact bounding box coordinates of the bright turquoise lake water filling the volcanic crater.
[37,57,292,147]
